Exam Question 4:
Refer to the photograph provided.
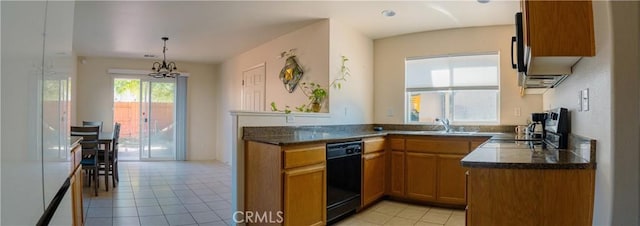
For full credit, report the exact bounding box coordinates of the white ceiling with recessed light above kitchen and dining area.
[73,0,519,63]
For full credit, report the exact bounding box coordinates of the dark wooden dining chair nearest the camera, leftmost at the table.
[71,126,100,196]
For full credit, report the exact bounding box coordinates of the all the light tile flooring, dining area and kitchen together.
[84,161,465,226]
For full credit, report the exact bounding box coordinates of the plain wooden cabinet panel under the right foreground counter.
[466,168,595,225]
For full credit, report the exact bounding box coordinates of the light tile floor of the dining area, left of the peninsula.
[84,161,231,226]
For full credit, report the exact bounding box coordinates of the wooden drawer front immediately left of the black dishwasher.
[283,144,326,169]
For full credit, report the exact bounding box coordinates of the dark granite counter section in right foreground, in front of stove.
[461,139,596,169]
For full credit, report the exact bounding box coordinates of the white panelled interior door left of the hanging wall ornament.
[242,64,266,111]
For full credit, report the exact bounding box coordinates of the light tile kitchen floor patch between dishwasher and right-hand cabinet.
[336,200,465,226]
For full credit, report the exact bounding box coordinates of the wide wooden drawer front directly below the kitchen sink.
[406,139,469,154]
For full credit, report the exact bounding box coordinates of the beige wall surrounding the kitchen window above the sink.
[374,25,542,125]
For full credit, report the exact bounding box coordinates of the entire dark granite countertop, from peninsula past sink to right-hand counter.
[243,126,596,169]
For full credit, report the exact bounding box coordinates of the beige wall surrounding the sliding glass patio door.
[72,57,217,160]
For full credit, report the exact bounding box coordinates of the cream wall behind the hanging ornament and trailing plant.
[215,19,373,162]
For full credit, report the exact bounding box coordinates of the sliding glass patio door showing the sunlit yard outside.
[113,78,176,160]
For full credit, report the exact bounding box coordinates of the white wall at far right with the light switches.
[543,1,640,225]
